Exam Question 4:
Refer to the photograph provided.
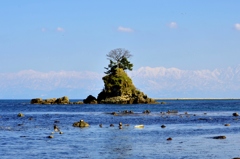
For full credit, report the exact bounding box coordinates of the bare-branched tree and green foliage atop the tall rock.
[105,48,133,74]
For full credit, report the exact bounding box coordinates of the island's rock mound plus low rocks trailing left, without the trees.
[31,68,157,105]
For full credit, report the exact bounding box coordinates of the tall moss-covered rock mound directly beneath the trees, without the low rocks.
[97,68,156,104]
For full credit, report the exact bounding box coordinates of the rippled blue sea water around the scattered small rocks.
[0,100,240,159]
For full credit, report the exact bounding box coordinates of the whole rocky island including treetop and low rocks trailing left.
[31,48,156,104]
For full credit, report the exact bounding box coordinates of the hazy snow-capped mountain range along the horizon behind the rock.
[0,65,240,99]
